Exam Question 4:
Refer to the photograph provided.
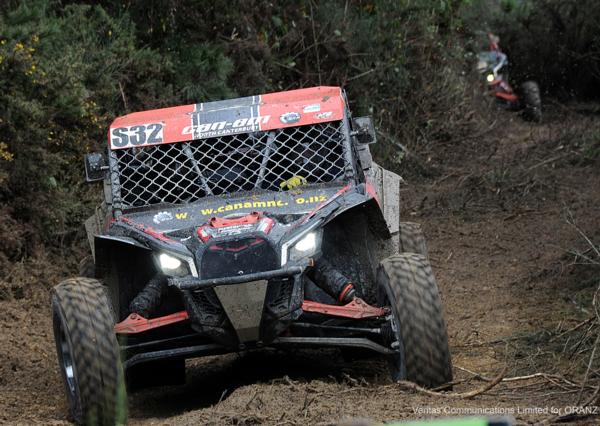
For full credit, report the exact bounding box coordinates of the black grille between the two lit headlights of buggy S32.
[200,238,278,279]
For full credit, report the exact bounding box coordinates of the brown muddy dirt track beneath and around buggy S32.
[0,105,600,425]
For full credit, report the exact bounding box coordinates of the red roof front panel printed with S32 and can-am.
[109,86,345,149]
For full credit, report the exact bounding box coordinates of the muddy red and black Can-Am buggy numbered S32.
[52,87,452,424]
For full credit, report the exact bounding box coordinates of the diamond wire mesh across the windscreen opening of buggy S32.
[114,121,347,206]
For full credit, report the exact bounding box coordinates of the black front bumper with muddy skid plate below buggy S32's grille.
[167,259,312,347]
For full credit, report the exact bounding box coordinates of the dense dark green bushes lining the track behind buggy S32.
[8,0,600,266]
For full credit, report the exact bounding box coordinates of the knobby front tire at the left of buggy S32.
[52,277,127,425]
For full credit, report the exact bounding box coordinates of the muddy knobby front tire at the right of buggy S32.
[377,253,452,388]
